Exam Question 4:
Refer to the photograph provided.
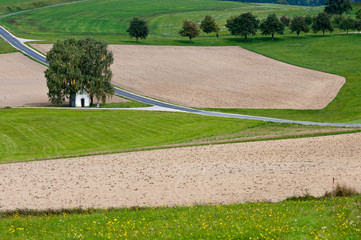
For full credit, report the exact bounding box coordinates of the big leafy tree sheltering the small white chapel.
[45,38,114,104]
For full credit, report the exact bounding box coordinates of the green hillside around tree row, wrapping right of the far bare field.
[2,0,361,122]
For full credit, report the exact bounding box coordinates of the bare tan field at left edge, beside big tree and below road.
[0,53,127,107]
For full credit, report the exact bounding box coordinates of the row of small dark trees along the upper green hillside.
[127,0,361,42]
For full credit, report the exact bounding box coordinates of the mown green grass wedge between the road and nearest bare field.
[0,109,359,163]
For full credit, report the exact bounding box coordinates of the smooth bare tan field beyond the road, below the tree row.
[32,44,345,109]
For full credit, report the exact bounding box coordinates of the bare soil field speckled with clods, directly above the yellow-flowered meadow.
[0,133,361,210]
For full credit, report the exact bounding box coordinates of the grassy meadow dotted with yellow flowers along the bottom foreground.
[0,197,361,240]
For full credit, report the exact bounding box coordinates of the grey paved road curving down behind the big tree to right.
[0,26,361,127]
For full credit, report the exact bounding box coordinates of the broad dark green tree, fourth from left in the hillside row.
[226,12,259,41]
